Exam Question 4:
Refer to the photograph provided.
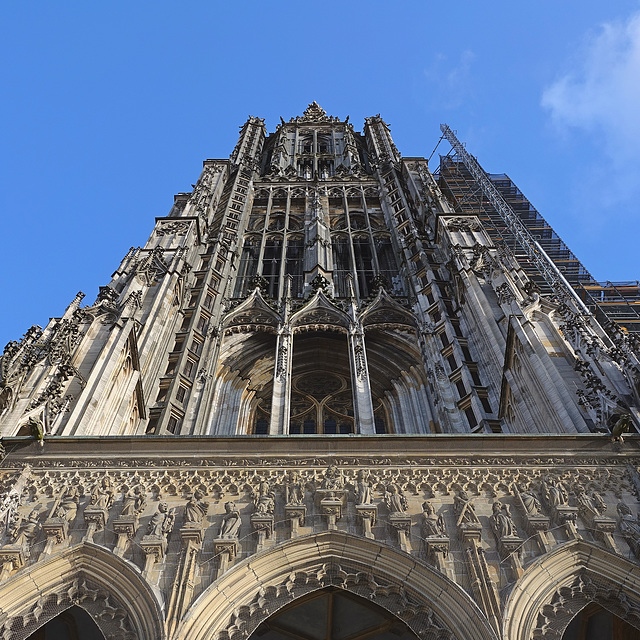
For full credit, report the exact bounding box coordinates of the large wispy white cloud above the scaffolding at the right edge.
[542,13,640,164]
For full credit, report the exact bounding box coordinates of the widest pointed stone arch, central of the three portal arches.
[178,531,496,640]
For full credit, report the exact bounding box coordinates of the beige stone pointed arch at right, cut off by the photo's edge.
[503,540,640,640]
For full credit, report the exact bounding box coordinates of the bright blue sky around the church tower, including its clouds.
[0,0,640,348]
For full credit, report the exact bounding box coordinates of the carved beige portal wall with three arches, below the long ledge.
[0,437,640,640]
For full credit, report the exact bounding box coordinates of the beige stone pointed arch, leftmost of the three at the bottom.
[0,542,165,640]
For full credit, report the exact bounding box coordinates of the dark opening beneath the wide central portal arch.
[249,588,417,640]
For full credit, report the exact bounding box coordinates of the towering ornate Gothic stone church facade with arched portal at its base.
[0,102,640,640]
